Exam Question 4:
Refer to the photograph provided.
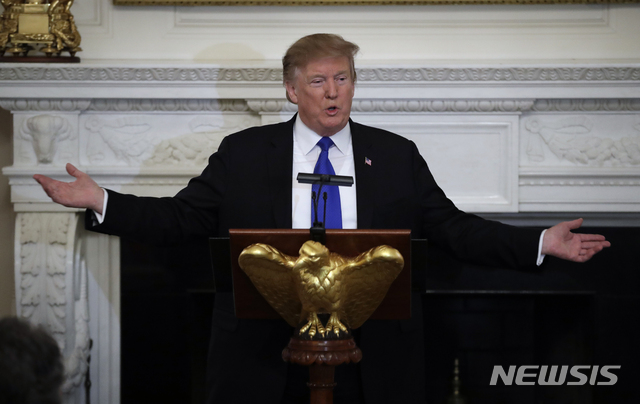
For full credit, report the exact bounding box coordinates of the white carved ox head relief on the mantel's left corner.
[22,115,71,164]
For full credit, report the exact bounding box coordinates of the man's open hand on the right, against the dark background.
[542,219,611,262]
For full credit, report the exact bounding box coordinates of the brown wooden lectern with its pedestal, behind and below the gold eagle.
[211,229,411,404]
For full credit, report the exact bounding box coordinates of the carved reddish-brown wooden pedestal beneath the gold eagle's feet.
[282,337,362,404]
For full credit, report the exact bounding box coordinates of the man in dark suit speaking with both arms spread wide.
[34,34,609,404]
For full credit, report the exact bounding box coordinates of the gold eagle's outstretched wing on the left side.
[238,243,301,327]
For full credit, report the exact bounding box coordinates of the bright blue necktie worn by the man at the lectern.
[311,137,342,229]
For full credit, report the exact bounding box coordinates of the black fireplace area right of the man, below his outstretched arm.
[423,228,640,404]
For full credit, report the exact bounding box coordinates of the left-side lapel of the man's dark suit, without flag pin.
[267,116,295,229]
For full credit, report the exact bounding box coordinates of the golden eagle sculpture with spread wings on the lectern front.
[238,241,404,338]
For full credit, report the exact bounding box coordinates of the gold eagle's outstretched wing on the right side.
[340,245,404,329]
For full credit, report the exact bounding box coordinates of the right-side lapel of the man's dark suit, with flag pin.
[349,120,376,229]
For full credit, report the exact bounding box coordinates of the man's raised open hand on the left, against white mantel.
[33,163,104,214]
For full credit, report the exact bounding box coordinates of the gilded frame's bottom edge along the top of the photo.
[113,0,640,6]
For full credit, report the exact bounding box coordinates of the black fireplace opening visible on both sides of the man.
[121,228,640,404]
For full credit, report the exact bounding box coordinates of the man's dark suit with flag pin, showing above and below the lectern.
[89,115,540,403]
